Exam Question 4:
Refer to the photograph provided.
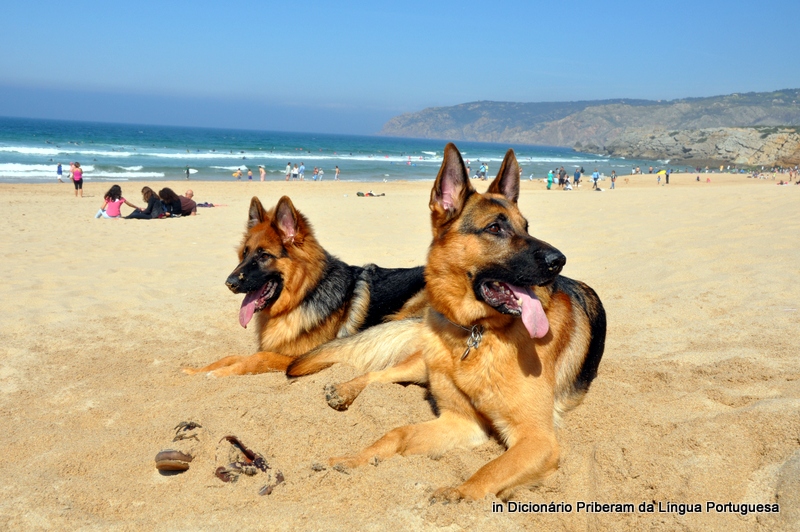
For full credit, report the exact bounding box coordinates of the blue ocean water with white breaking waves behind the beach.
[0,117,664,183]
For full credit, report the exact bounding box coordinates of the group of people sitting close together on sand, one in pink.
[94,185,203,220]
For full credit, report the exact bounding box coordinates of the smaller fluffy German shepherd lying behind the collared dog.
[184,196,425,376]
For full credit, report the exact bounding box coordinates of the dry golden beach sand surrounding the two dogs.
[0,174,800,532]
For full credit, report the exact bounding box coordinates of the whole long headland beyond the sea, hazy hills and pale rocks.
[379,89,800,164]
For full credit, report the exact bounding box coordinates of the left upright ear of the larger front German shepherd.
[430,142,475,225]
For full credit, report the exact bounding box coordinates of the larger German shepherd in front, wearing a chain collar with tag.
[288,144,606,501]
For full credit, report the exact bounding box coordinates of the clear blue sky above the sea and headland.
[0,0,800,134]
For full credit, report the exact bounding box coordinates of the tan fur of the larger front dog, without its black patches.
[327,144,605,501]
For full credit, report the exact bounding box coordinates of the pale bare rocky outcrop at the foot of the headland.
[600,127,800,166]
